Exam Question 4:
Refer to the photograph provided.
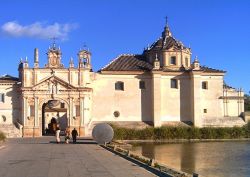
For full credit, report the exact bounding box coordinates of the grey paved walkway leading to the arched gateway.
[0,137,155,177]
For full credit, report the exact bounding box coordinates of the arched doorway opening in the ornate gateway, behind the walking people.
[42,100,69,135]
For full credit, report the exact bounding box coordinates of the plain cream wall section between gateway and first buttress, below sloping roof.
[92,75,152,122]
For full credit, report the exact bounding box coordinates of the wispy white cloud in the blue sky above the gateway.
[1,21,77,40]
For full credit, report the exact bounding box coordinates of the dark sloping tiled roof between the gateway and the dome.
[101,54,153,71]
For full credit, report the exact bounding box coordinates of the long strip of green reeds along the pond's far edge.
[111,122,250,140]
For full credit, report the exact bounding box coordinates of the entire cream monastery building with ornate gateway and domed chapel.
[0,23,244,136]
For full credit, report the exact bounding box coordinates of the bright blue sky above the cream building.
[0,0,250,92]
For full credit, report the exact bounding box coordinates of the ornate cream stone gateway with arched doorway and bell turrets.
[19,45,92,136]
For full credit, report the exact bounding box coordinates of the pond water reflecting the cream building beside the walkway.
[132,142,250,177]
